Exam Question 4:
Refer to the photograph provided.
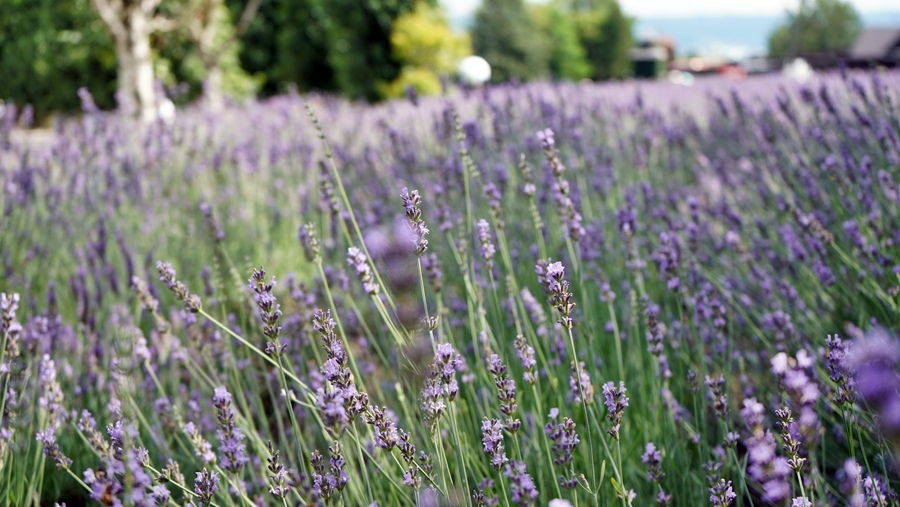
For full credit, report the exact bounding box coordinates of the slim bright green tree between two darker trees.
[529,3,592,80]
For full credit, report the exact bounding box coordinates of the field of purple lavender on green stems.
[0,72,900,507]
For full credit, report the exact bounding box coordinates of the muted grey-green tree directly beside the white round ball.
[471,0,549,82]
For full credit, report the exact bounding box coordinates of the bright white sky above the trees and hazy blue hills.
[441,0,898,17]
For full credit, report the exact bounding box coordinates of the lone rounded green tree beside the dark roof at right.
[769,0,862,58]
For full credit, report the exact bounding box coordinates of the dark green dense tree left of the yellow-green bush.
[232,0,418,100]
